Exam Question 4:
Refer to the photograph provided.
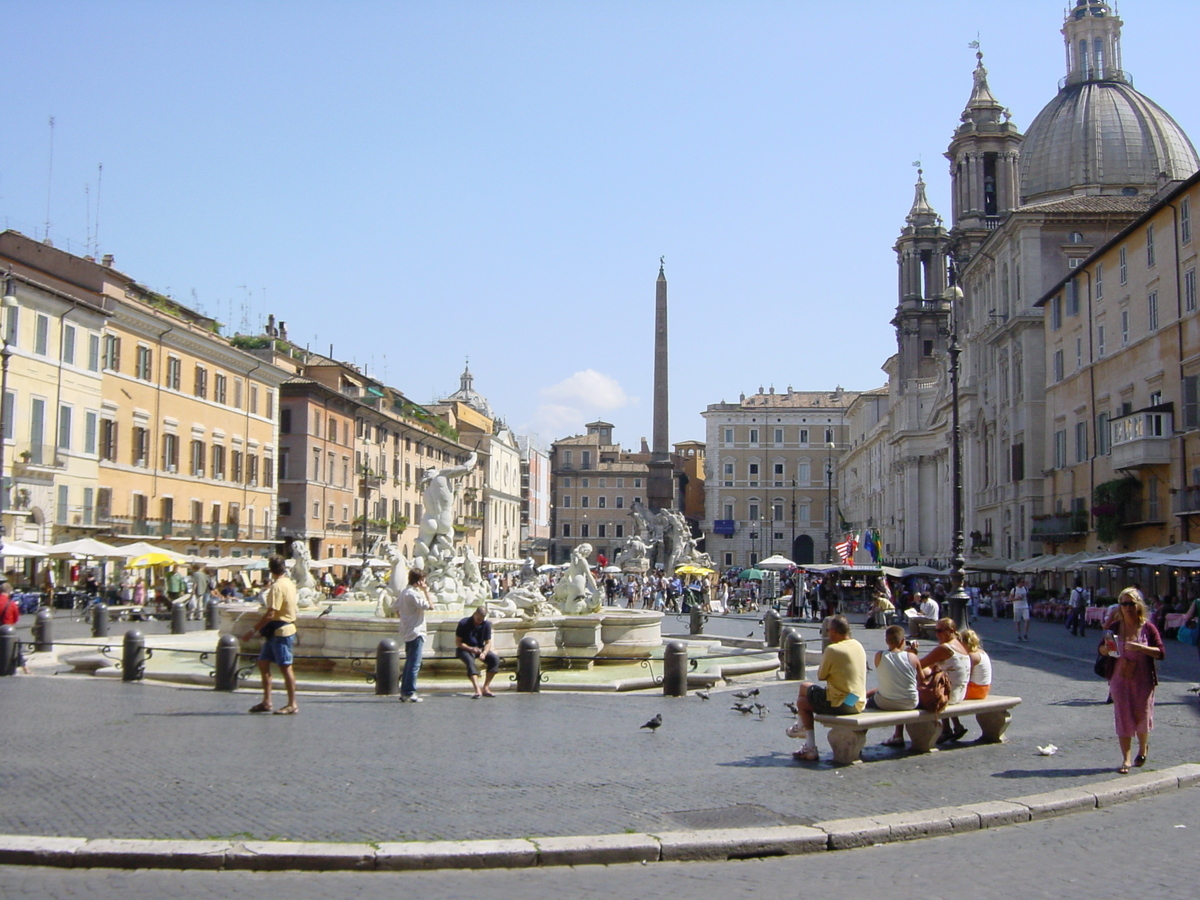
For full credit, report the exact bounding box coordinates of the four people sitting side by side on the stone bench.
[787,616,991,761]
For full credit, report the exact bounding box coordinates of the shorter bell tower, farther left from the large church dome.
[892,169,950,394]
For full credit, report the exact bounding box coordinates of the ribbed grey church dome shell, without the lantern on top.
[1021,80,1200,203]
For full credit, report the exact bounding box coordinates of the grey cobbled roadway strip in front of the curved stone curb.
[0,787,1200,900]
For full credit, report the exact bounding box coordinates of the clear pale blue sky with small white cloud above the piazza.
[0,0,1200,449]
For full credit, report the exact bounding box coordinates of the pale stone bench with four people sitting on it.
[812,695,1021,766]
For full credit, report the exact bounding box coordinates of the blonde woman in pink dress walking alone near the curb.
[1109,588,1166,775]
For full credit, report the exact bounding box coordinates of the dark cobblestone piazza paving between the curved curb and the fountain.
[0,617,1200,841]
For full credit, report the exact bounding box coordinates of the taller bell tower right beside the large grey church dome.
[946,50,1022,257]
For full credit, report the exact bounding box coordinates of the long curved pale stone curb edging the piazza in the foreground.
[0,763,1200,871]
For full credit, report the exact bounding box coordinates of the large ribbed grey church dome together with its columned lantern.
[1021,0,1200,203]
